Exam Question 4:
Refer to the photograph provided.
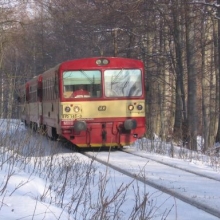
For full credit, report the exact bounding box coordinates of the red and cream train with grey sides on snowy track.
[18,57,146,148]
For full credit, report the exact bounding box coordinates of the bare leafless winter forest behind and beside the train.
[0,0,220,152]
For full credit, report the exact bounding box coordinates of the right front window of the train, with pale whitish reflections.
[104,69,143,97]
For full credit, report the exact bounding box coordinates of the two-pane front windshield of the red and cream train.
[63,69,143,98]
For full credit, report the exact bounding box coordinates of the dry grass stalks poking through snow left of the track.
[0,120,168,220]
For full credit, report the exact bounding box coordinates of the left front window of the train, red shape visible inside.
[63,70,101,98]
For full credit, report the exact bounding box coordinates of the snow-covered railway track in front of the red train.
[83,149,220,218]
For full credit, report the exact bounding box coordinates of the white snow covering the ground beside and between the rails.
[0,120,220,220]
